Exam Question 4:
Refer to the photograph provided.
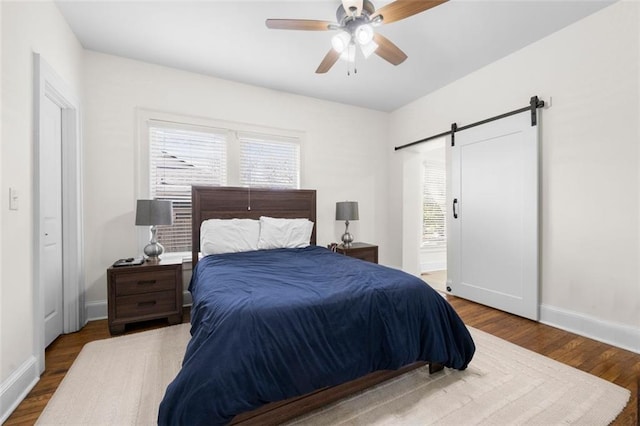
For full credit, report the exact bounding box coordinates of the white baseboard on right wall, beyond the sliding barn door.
[540,305,640,354]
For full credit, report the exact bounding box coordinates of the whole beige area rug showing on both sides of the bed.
[37,324,630,425]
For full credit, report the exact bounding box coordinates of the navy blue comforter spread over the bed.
[158,246,475,425]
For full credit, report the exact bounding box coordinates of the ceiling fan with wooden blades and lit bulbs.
[266,0,447,74]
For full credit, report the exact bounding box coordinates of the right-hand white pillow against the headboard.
[258,216,313,249]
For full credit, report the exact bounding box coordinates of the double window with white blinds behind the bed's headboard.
[146,119,300,253]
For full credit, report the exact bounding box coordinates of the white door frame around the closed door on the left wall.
[33,53,86,374]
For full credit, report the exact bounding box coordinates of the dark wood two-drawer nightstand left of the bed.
[107,259,182,334]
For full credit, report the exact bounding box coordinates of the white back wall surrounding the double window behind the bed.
[84,51,389,316]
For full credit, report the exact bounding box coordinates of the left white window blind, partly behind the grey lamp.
[149,121,227,253]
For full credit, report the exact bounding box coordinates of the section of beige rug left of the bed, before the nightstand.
[36,324,191,426]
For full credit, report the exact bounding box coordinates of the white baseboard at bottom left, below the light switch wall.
[0,356,40,424]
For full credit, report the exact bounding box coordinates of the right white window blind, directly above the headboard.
[238,133,300,188]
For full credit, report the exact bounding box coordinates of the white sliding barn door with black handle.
[447,112,539,320]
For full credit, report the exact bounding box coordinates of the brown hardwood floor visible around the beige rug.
[5,296,640,425]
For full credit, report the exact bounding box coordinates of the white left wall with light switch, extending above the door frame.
[0,1,82,419]
